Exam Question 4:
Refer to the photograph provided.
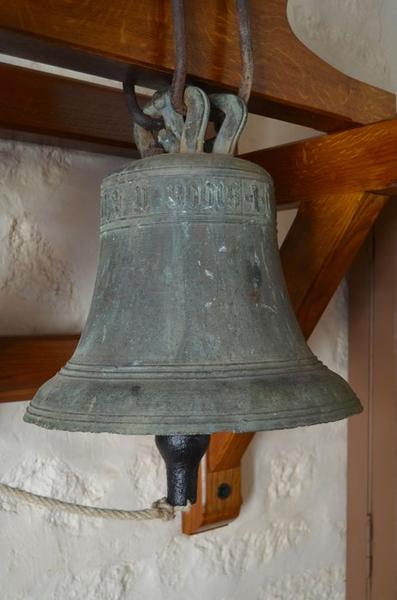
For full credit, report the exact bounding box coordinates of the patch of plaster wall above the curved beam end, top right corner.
[288,0,397,91]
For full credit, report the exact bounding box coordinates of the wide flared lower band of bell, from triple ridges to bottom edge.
[24,363,362,435]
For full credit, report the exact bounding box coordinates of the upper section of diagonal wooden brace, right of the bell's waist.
[280,192,388,339]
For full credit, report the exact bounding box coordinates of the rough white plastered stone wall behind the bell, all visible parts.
[0,0,397,600]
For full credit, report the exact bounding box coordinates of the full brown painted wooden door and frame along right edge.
[346,202,397,600]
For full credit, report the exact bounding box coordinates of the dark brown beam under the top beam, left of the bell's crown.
[0,64,137,156]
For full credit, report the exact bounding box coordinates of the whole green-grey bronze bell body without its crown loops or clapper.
[25,154,361,435]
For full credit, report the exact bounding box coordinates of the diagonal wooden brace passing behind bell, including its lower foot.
[183,192,388,534]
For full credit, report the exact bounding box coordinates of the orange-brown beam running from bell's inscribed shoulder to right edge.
[241,119,397,204]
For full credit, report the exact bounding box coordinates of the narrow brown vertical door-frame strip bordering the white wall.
[346,233,374,600]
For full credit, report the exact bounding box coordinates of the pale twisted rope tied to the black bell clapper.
[0,483,190,521]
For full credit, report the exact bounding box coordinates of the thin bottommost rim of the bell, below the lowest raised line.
[23,399,363,435]
